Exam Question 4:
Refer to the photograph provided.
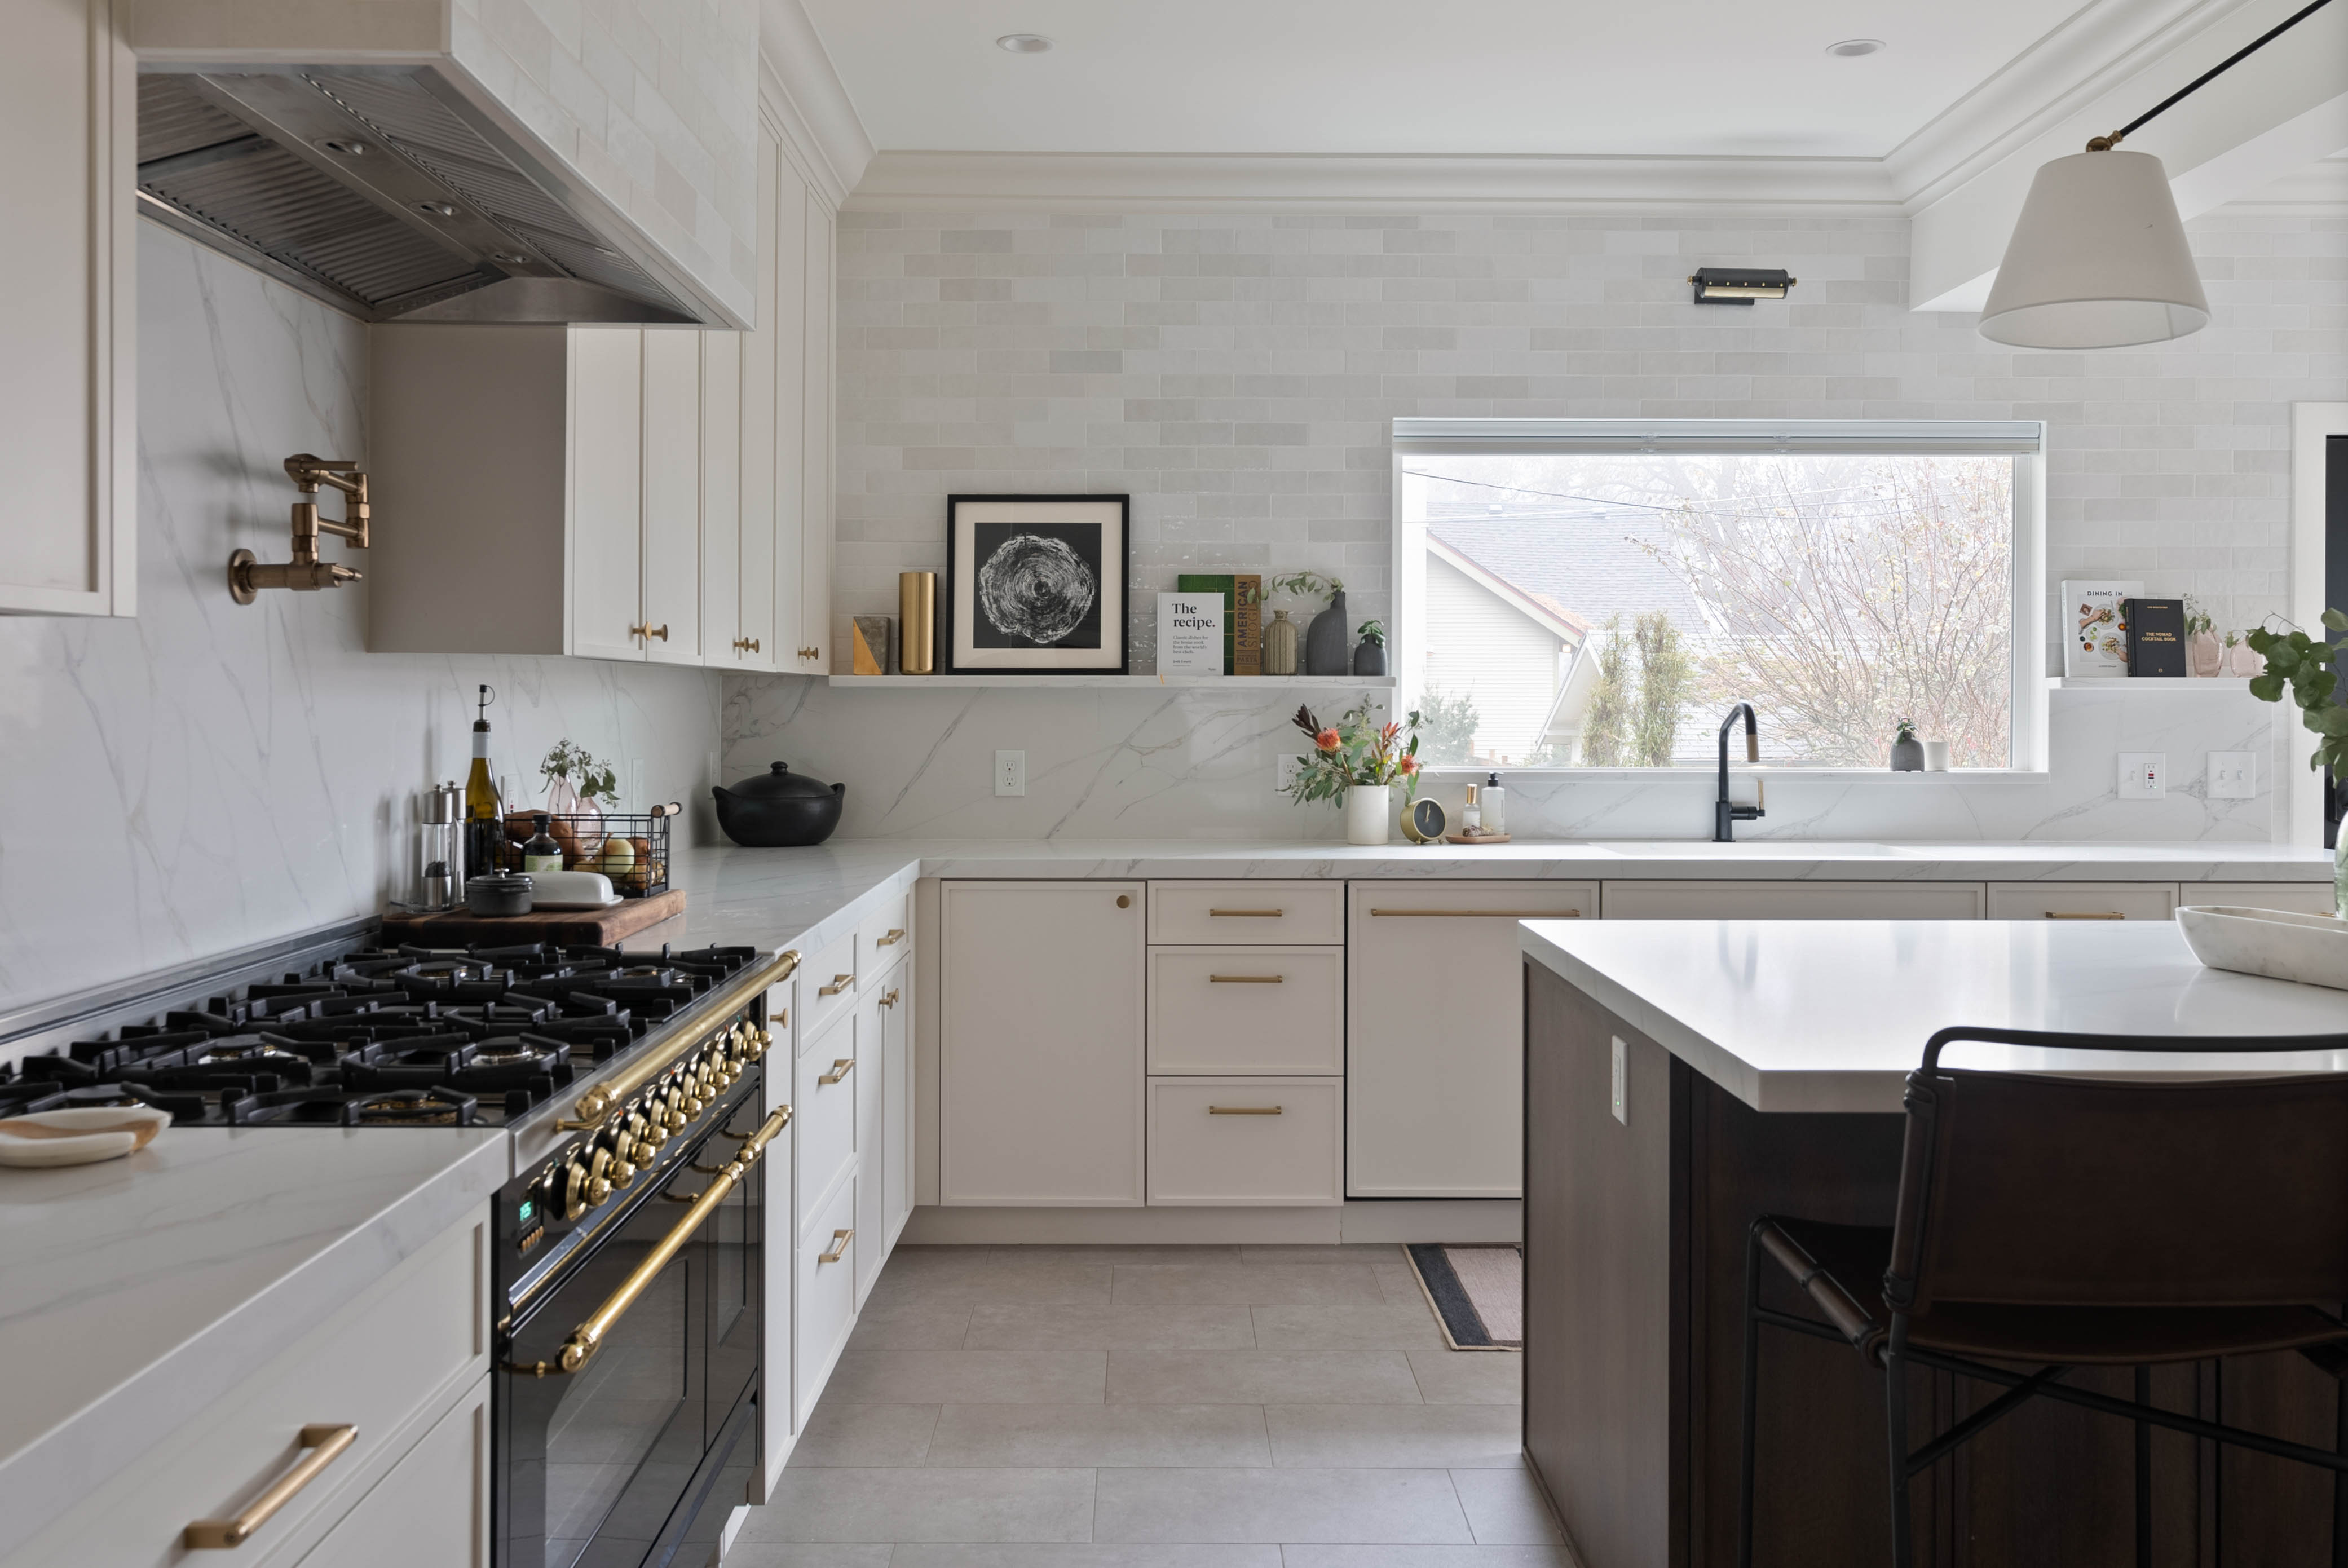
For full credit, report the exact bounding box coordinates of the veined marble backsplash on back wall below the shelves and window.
[723,676,2280,843]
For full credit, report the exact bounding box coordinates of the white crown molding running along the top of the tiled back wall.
[848,153,1900,214]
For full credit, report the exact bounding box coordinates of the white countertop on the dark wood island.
[1519,920,2348,1112]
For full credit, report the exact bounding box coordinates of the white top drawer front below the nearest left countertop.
[7,1220,488,1568]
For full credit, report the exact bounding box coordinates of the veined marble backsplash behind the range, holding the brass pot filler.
[0,223,718,1012]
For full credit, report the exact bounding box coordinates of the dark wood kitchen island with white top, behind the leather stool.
[1521,920,2348,1568]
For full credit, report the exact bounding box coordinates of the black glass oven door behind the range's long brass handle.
[498,1101,763,1568]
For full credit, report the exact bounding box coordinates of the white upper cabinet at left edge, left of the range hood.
[0,0,139,615]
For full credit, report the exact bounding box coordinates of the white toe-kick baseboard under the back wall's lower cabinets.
[902,1197,1524,1247]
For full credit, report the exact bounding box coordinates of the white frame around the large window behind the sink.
[1390,418,2050,777]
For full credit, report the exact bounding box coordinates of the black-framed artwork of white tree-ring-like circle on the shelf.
[944,495,1132,676]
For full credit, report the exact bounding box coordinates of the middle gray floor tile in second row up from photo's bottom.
[1092,1469,1472,1542]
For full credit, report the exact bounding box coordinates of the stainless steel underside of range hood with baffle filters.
[139,66,716,324]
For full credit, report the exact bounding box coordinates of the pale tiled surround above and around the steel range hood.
[129,0,758,329]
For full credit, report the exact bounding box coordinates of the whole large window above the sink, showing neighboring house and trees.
[1394,420,2043,770]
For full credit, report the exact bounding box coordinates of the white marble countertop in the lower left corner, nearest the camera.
[0,1127,505,1556]
